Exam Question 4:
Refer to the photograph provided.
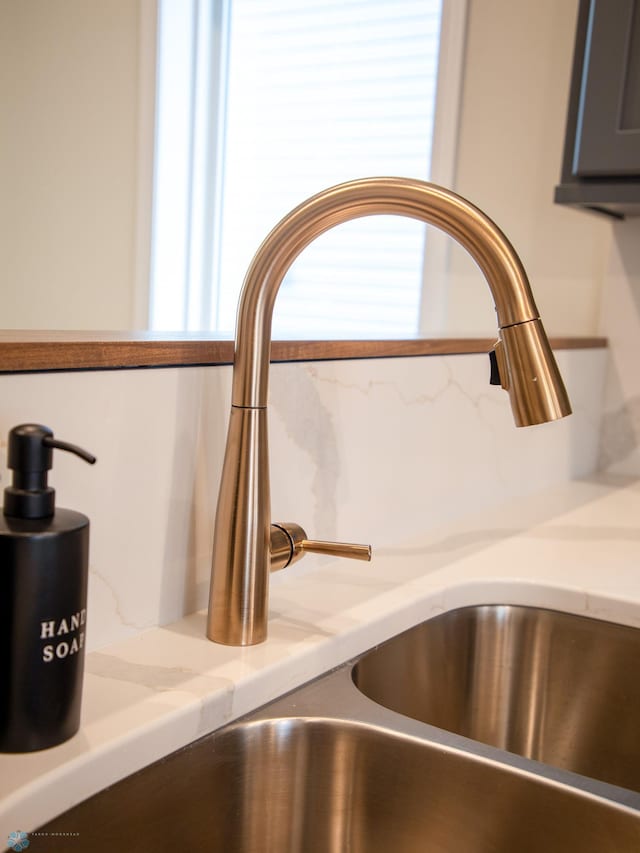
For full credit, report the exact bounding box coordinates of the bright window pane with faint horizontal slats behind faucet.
[154,0,448,338]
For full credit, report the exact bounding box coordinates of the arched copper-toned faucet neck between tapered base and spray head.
[232,178,538,408]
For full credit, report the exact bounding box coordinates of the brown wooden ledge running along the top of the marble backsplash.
[0,332,607,373]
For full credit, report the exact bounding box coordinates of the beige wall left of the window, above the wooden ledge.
[0,0,138,329]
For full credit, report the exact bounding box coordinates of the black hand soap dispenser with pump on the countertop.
[0,424,96,752]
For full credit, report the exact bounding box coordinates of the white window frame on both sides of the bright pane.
[141,0,468,336]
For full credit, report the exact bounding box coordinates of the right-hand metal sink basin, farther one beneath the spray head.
[354,606,640,792]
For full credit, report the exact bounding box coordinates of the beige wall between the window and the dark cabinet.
[449,0,611,335]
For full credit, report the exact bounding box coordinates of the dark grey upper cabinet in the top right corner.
[555,0,640,217]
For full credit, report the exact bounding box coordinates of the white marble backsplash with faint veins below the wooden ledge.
[0,349,607,650]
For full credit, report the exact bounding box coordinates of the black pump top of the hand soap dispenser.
[4,424,96,518]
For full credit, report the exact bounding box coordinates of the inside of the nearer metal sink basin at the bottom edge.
[38,719,640,853]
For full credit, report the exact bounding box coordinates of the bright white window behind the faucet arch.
[150,0,464,337]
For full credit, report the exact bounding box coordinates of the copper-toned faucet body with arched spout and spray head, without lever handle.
[207,178,571,645]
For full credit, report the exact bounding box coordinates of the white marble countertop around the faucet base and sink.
[0,477,640,841]
